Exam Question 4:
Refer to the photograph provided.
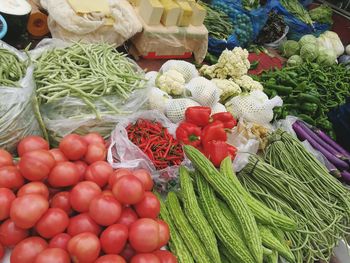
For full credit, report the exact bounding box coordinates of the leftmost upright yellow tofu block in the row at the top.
[139,0,164,26]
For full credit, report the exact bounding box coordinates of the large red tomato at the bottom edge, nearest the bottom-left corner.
[10,237,47,263]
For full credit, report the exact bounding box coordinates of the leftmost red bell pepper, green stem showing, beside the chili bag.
[176,122,202,147]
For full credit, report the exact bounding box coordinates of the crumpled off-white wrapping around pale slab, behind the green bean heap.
[41,0,142,46]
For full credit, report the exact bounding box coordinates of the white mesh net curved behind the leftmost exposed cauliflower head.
[160,60,199,83]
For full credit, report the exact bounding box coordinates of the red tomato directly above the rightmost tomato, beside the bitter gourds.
[134,192,160,219]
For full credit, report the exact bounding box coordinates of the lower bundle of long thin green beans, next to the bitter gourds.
[239,156,349,263]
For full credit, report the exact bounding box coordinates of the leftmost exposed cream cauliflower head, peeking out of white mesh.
[156,69,186,96]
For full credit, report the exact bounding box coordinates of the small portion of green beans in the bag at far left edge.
[0,48,27,87]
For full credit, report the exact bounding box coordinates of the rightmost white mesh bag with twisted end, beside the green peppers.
[226,91,283,124]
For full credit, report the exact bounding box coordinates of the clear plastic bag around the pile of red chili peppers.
[107,111,185,192]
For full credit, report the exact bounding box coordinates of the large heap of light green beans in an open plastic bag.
[34,43,145,117]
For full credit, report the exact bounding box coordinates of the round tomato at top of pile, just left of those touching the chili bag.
[59,134,88,161]
